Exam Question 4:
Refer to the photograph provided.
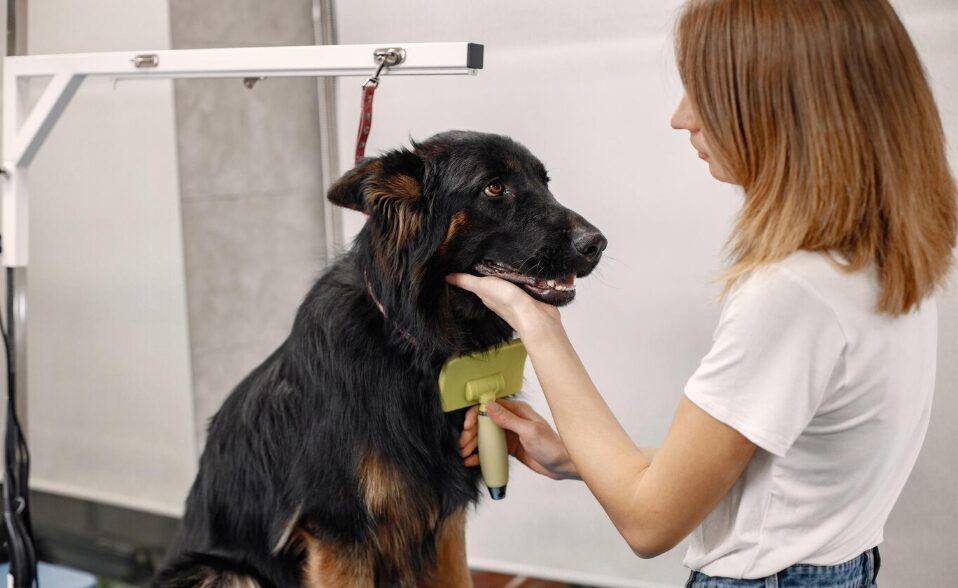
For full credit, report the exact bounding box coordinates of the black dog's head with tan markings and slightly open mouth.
[329,131,606,354]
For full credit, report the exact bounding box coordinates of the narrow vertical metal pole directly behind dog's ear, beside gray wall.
[313,0,343,264]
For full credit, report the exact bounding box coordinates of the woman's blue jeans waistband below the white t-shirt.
[685,547,881,588]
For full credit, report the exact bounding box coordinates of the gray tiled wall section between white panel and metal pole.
[170,0,325,448]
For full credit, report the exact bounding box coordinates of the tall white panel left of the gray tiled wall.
[7,0,196,515]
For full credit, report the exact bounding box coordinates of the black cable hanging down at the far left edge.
[0,268,39,588]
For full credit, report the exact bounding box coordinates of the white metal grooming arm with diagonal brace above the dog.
[2,43,483,267]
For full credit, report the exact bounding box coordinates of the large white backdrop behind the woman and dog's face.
[336,0,958,588]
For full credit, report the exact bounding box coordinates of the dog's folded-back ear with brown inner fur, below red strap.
[326,149,424,214]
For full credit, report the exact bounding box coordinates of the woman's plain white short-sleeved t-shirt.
[685,251,938,579]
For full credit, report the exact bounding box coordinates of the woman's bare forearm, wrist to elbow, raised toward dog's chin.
[522,321,654,539]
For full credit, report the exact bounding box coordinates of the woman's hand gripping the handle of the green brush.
[459,400,579,480]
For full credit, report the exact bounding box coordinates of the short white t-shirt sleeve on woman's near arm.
[685,266,845,457]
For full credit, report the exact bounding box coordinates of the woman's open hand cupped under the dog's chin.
[446,274,562,339]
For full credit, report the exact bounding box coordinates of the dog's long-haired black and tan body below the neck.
[165,258,488,586]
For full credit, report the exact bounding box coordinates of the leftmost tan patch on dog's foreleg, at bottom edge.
[296,528,373,588]
